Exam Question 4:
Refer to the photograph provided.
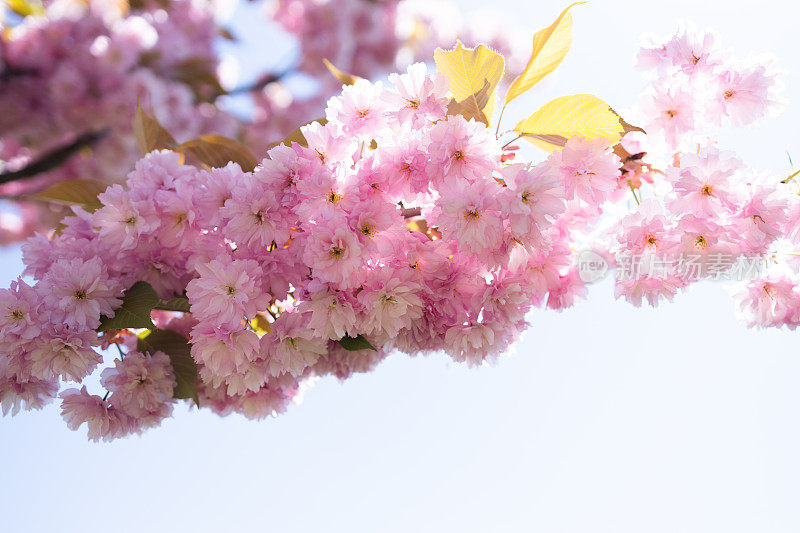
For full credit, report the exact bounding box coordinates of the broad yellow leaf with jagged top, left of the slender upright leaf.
[433,41,505,122]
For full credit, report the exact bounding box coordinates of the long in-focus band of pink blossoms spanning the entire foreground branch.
[0,23,800,439]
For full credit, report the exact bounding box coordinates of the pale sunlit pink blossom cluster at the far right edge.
[610,26,800,328]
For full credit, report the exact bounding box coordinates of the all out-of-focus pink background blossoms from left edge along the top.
[0,0,528,251]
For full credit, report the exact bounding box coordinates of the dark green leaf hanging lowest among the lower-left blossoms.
[137,329,200,407]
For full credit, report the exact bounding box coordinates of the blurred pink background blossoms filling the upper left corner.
[0,0,238,244]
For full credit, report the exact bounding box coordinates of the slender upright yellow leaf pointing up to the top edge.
[506,2,585,103]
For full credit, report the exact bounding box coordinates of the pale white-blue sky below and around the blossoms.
[0,0,800,533]
